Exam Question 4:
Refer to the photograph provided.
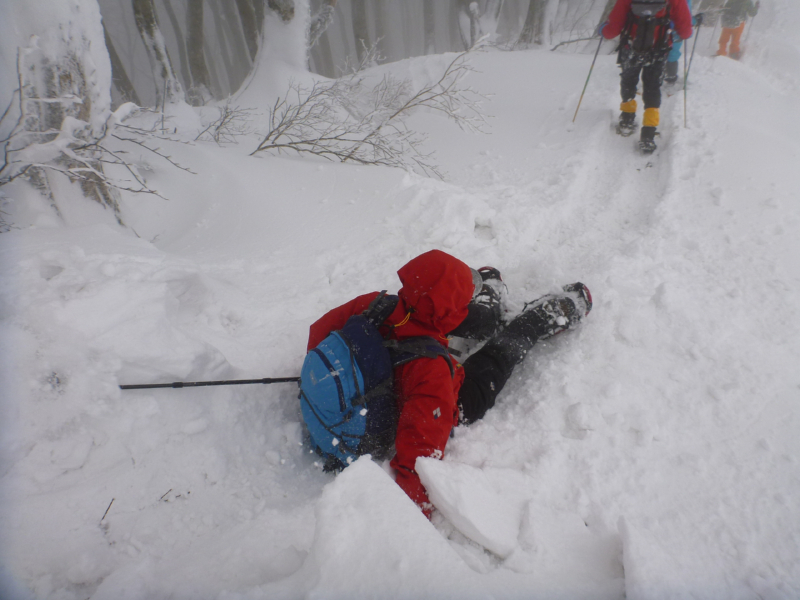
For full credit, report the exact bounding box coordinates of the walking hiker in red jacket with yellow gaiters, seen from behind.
[601,0,692,154]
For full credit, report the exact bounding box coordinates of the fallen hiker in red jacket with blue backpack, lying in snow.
[300,250,592,517]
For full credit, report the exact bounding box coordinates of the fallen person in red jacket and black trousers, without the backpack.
[301,250,592,518]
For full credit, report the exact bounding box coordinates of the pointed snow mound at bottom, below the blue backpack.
[255,456,478,598]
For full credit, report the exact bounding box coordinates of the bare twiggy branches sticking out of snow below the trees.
[251,50,485,178]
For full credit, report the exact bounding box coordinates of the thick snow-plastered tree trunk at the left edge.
[0,0,119,220]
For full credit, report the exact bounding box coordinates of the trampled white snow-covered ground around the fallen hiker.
[0,0,800,600]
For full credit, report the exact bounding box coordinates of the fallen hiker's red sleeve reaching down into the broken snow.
[391,358,464,517]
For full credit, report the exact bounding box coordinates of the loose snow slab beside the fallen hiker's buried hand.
[416,458,522,558]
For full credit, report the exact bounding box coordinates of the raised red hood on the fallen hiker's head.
[390,250,475,338]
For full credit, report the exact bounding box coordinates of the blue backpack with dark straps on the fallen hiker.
[300,291,454,472]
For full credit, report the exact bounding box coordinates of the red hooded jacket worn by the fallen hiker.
[308,250,474,516]
